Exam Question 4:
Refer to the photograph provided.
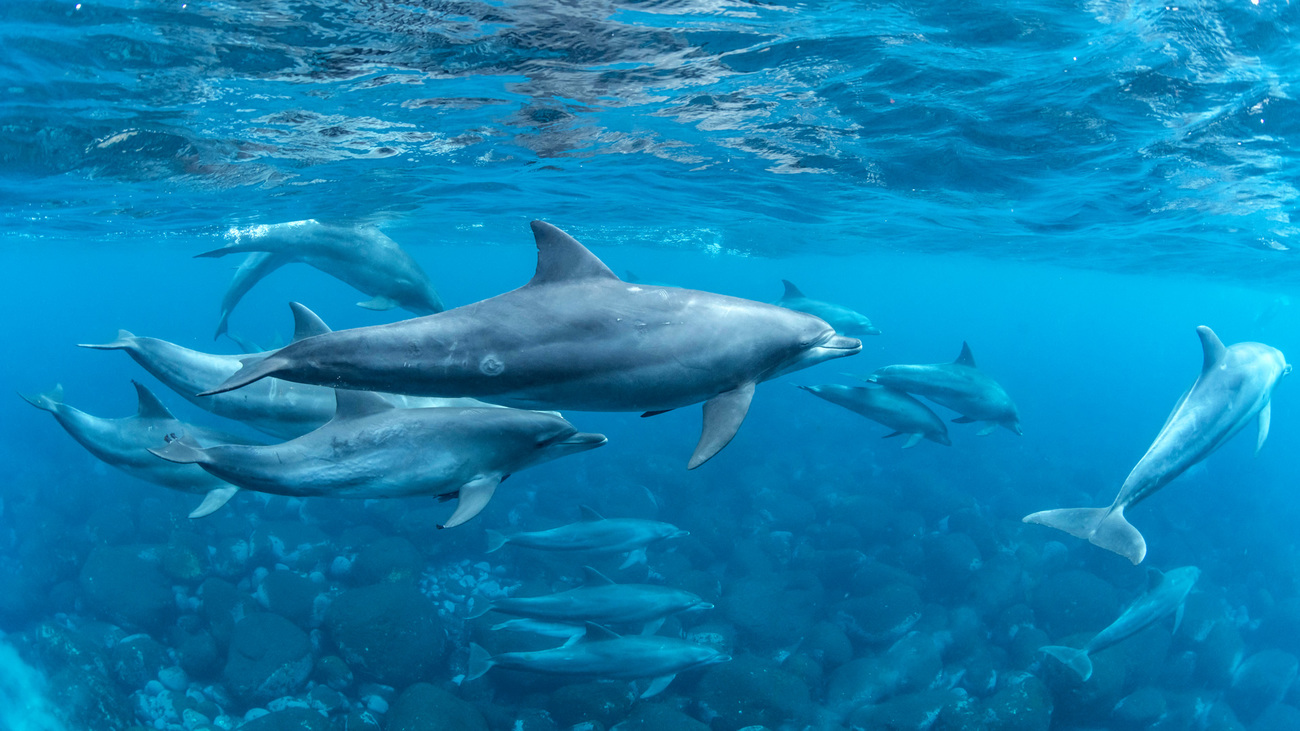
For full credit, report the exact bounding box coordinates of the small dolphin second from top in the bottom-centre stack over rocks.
[471,566,714,635]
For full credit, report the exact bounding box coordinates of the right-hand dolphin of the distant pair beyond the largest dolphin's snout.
[866,342,1024,436]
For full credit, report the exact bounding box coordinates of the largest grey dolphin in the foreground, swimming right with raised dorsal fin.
[195,221,862,468]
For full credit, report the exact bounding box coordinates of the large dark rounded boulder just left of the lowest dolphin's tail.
[325,583,446,688]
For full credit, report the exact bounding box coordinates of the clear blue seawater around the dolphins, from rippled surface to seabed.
[0,0,1300,731]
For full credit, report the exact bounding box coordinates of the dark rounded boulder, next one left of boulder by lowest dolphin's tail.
[222,613,312,704]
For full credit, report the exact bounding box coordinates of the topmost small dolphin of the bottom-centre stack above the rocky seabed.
[486,505,690,568]
